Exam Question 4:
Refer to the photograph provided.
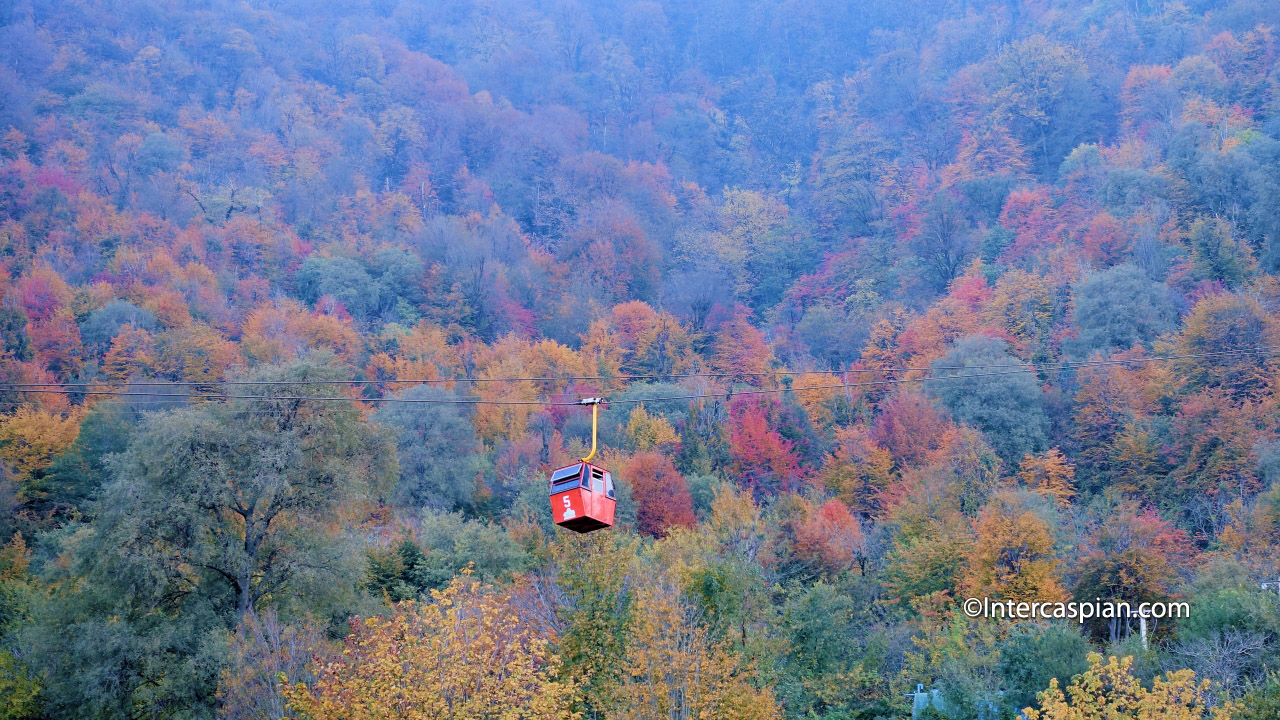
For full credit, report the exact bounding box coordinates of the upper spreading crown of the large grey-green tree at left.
[96,355,389,616]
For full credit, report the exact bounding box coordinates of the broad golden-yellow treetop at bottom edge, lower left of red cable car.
[283,577,577,720]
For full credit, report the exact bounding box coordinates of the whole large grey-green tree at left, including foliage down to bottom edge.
[19,355,392,719]
